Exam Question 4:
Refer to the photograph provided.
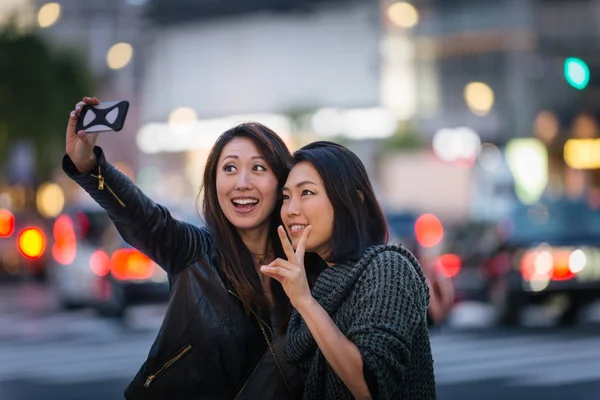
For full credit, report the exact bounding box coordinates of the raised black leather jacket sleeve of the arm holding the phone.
[62,146,212,274]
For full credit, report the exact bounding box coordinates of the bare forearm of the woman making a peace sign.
[297,299,371,399]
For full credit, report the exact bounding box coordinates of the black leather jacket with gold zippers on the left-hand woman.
[63,147,303,400]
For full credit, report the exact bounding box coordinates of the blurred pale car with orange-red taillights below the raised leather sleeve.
[48,208,169,317]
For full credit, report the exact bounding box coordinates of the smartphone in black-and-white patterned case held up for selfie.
[75,100,129,133]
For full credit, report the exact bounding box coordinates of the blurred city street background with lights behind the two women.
[0,0,600,400]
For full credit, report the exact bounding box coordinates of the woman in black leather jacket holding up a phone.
[63,97,322,400]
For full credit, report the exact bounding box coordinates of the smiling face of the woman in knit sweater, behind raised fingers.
[281,161,333,258]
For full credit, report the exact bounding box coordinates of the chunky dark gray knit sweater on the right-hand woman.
[286,245,436,400]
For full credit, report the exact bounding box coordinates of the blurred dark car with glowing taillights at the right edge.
[484,200,600,325]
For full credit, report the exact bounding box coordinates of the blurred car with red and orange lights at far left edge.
[0,209,49,280]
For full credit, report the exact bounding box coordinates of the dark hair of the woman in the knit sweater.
[294,141,389,263]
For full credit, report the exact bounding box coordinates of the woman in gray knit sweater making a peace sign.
[261,142,436,400]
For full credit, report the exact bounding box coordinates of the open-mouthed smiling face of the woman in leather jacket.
[216,137,278,231]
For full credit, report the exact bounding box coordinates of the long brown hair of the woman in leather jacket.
[199,122,292,319]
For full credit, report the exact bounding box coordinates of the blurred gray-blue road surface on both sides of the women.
[0,285,600,400]
